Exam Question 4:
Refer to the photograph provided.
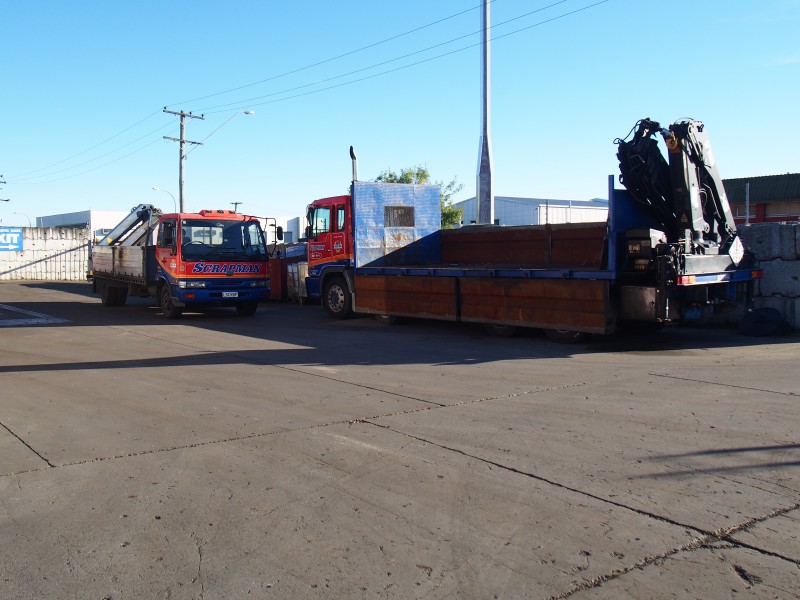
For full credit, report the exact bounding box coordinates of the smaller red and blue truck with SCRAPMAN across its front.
[91,204,270,319]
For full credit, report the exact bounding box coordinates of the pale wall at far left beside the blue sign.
[0,227,91,281]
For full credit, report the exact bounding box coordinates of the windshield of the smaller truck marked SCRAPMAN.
[181,219,267,262]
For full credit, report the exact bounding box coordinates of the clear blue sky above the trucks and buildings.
[0,0,800,226]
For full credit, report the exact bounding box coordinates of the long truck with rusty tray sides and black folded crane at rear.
[296,119,761,342]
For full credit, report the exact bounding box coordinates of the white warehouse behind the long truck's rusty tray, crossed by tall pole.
[453,196,608,225]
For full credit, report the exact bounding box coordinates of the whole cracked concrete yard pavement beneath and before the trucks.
[0,282,800,600]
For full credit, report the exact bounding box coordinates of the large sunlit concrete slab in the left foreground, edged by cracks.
[0,423,691,598]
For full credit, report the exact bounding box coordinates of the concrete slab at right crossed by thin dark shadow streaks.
[375,375,800,532]
